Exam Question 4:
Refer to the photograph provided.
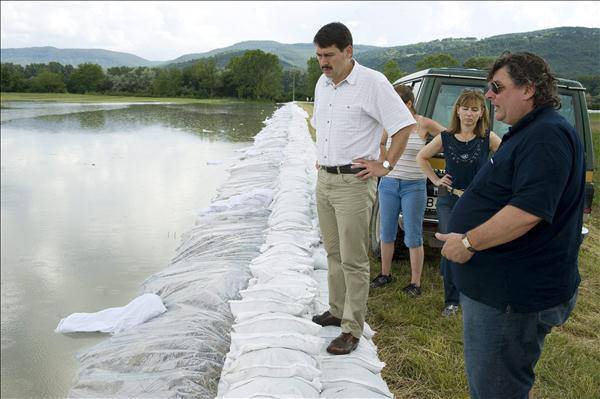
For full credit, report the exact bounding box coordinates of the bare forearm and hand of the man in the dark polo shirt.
[435,205,542,263]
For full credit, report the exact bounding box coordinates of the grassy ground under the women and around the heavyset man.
[298,103,600,399]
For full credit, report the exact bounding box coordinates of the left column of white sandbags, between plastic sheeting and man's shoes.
[218,107,324,398]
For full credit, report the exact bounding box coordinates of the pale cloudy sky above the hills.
[0,0,600,61]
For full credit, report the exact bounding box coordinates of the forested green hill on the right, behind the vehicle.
[356,27,600,78]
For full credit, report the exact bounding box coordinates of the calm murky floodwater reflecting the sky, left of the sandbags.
[0,102,275,398]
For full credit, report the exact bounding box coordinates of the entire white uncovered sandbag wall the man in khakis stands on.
[217,107,393,398]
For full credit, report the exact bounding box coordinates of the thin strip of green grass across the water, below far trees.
[0,93,248,104]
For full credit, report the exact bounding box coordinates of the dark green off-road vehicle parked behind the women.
[371,68,594,255]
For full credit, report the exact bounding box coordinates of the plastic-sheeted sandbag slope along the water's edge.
[69,106,293,398]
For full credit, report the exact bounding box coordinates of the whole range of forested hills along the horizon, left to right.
[1,27,600,78]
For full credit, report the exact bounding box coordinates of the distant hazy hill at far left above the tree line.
[0,46,161,68]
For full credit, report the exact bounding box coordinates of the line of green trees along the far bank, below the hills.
[0,50,600,109]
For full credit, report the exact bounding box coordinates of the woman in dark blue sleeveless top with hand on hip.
[417,90,501,316]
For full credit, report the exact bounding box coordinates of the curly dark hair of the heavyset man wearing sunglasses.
[488,52,560,109]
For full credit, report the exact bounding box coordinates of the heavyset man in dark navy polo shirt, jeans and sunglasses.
[438,53,585,399]
